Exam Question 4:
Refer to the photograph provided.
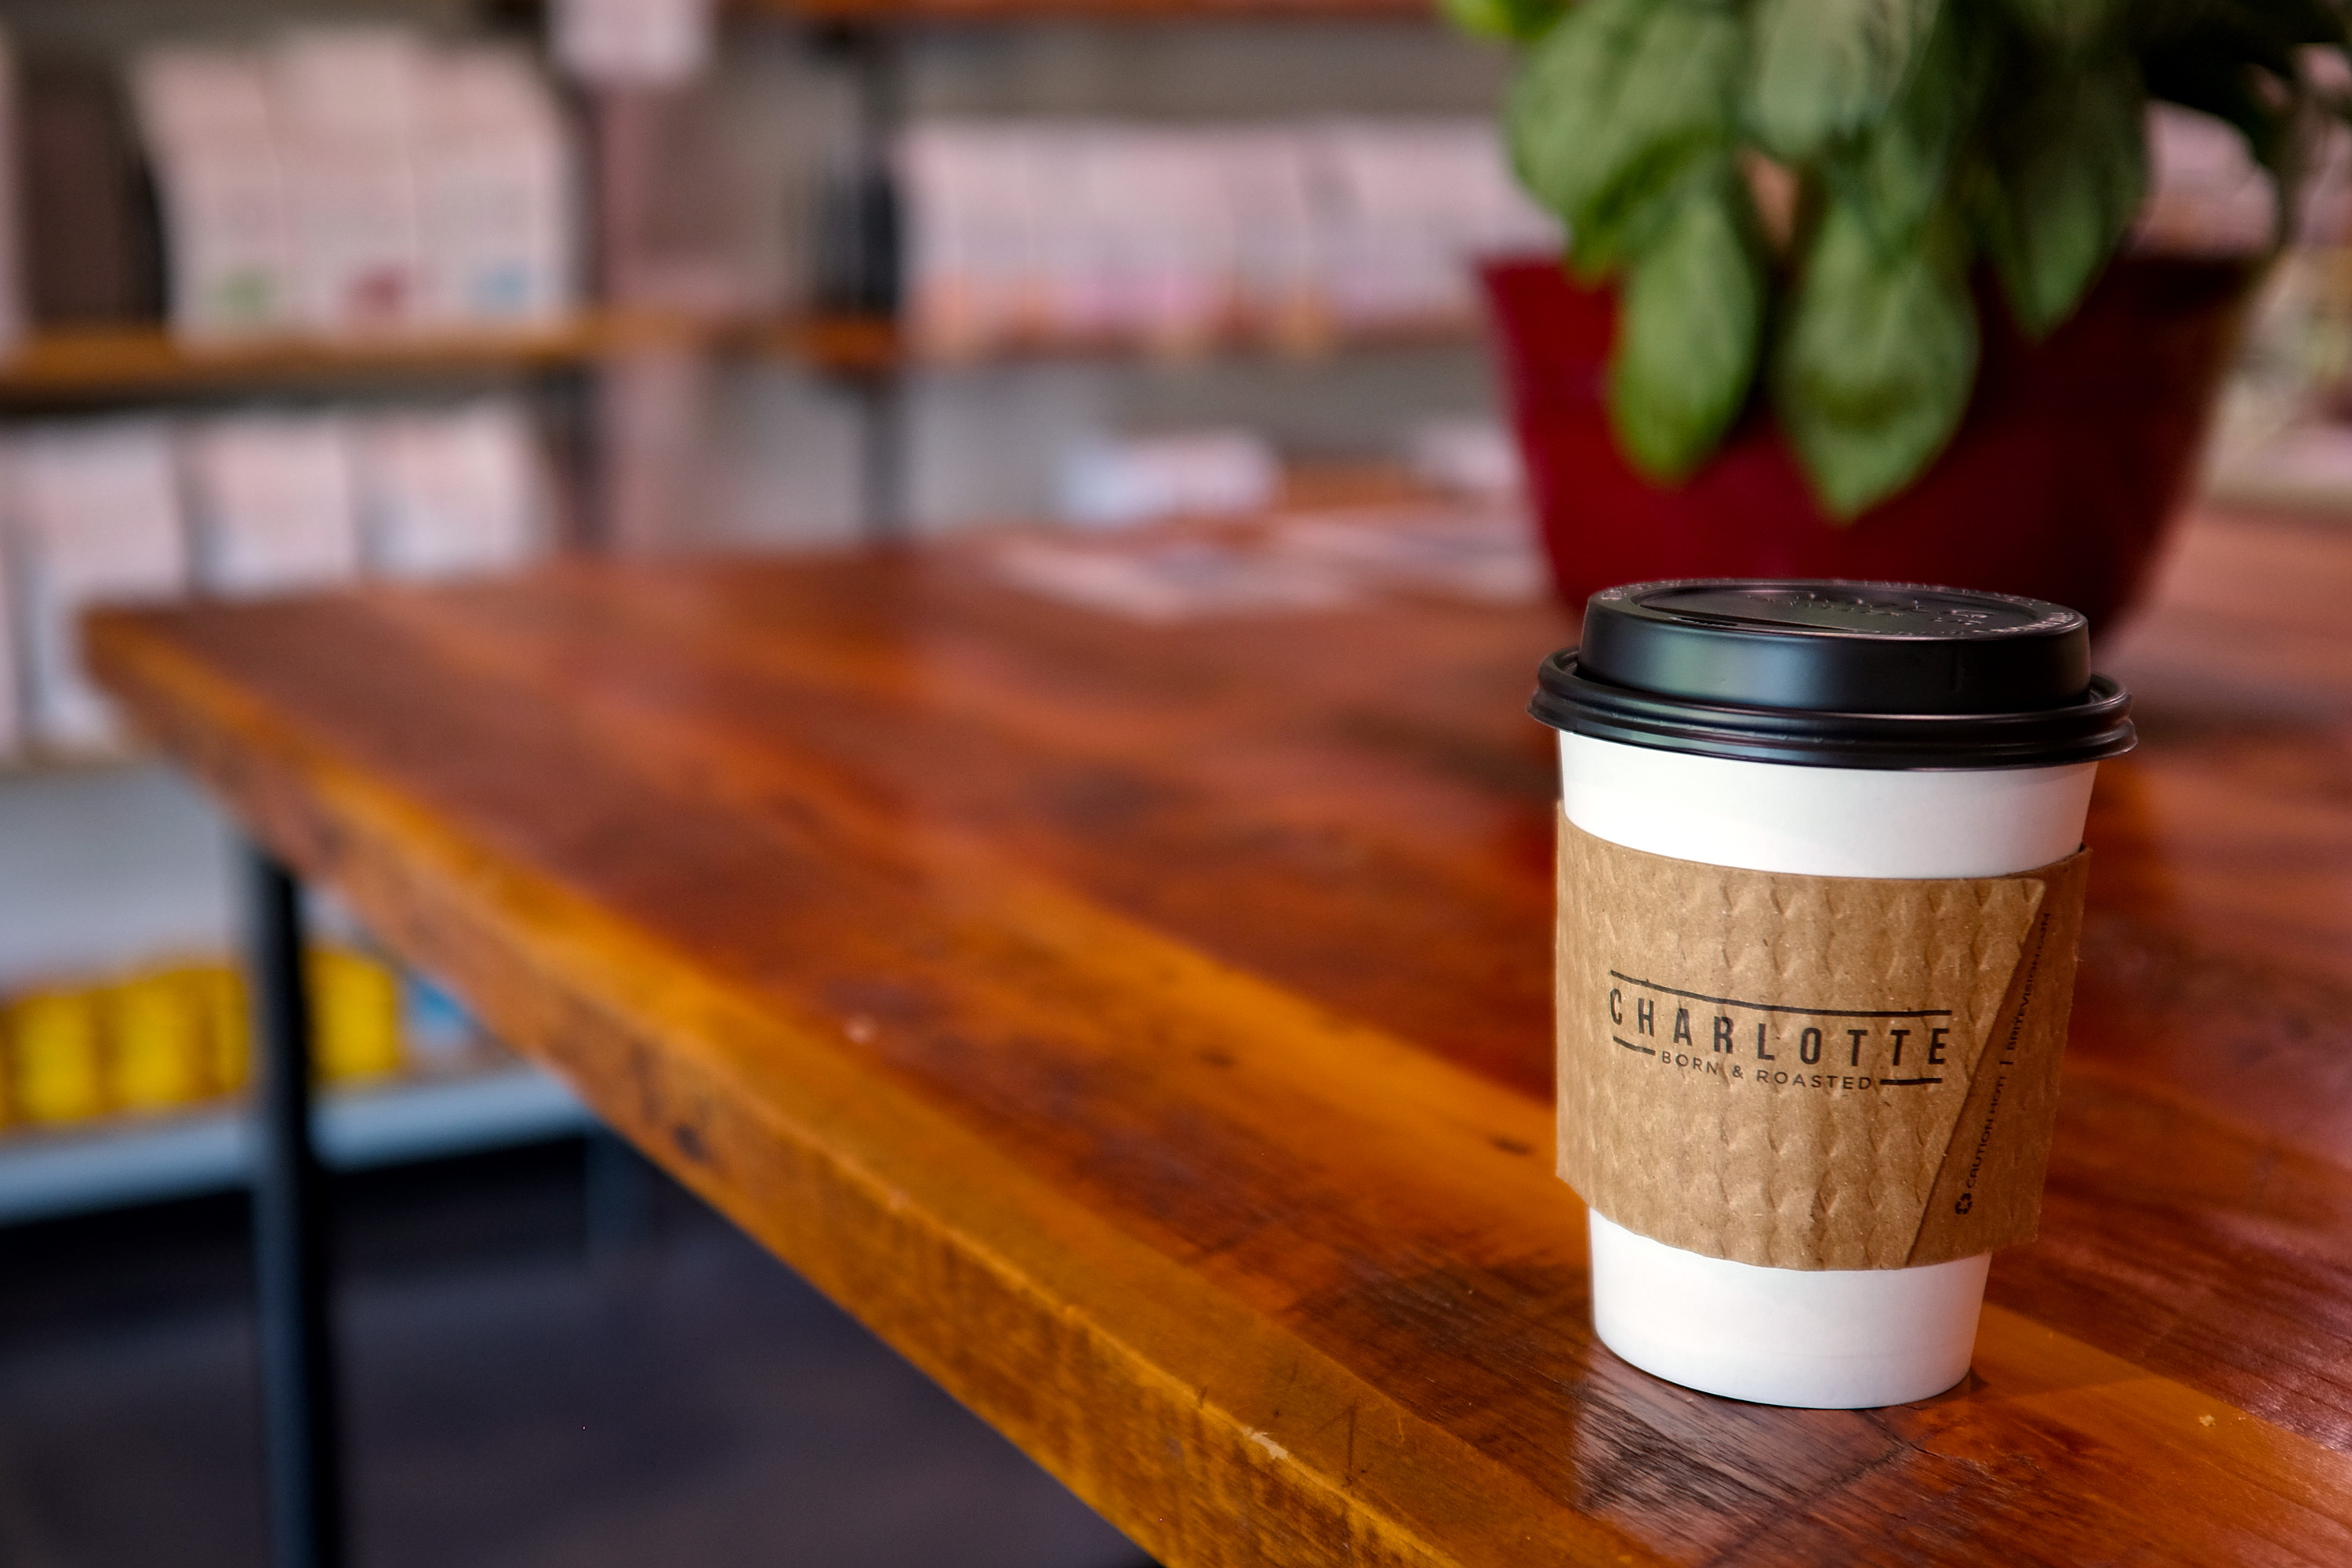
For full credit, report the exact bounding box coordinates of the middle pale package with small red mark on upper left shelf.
[268,26,430,334]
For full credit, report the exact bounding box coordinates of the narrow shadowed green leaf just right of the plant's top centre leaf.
[1823,5,1994,247]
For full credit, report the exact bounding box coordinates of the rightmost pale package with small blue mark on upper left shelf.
[419,49,579,325]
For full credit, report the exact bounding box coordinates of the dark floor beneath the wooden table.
[0,1145,1138,1568]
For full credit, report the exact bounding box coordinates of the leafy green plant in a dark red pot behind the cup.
[1446,0,2352,623]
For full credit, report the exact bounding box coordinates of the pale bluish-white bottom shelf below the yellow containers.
[0,1065,595,1225]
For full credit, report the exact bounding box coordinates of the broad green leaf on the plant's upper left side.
[1503,0,1743,275]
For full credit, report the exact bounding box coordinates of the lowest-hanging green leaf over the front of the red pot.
[1773,200,1978,517]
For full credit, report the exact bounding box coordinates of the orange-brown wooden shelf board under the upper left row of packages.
[0,313,717,405]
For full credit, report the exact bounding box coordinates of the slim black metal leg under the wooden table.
[247,846,343,1568]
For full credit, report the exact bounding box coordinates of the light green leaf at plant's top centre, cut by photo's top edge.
[1748,0,1940,162]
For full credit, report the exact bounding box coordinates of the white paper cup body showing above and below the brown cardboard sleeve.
[1559,734,2098,1408]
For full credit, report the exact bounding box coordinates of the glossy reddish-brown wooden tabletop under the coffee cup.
[94,517,2352,1566]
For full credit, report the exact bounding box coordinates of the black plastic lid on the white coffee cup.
[1529,579,2133,769]
